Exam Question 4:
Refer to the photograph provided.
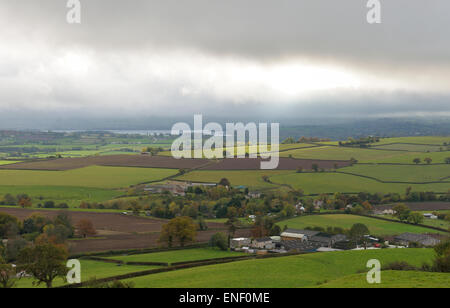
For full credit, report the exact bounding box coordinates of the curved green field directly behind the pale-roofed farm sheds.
[278,214,444,236]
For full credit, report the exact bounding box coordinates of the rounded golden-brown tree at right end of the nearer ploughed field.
[159,216,197,247]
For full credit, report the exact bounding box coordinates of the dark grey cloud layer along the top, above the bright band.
[1,0,450,64]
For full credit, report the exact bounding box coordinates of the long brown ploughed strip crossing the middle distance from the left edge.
[0,155,350,171]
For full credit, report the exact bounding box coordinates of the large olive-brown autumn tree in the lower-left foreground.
[18,243,69,288]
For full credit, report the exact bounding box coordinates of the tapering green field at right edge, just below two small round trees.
[339,164,450,187]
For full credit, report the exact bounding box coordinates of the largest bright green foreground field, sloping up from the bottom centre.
[122,249,434,288]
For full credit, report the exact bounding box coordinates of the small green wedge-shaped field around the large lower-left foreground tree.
[16,260,158,288]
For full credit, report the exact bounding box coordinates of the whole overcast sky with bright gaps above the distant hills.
[0,0,450,126]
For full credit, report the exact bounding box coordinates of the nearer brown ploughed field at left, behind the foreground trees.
[0,208,250,254]
